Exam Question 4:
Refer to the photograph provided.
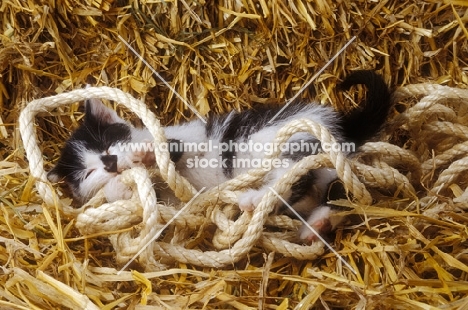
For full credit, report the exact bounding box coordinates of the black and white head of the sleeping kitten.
[47,99,152,203]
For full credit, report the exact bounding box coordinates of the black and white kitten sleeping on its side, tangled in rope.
[48,70,390,240]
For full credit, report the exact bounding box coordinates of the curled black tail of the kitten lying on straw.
[338,70,391,145]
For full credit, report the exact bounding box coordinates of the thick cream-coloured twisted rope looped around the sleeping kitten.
[19,84,468,270]
